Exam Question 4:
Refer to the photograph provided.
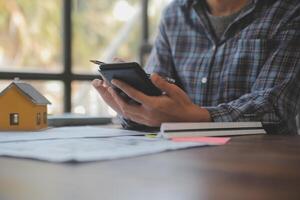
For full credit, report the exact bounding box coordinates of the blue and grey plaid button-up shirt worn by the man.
[141,0,300,134]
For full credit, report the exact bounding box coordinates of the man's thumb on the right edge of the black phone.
[151,74,179,96]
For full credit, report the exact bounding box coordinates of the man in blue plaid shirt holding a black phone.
[93,0,300,134]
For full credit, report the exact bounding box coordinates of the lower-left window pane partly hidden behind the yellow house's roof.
[0,80,63,114]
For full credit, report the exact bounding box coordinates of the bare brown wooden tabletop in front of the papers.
[0,135,300,200]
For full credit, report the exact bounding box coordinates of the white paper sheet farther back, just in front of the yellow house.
[0,126,146,143]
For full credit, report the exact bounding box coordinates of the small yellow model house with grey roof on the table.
[0,81,51,131]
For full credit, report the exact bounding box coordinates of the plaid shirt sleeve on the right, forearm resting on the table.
[206,17,300,134]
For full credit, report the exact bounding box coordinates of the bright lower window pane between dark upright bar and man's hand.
[72,81,116,116]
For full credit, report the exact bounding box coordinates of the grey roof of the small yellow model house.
[0,81,51,105]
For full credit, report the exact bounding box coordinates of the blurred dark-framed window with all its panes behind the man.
[0,0,171,116]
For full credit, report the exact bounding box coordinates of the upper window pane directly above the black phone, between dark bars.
[72,0,141,73]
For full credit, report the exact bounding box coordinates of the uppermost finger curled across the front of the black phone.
[112,79,150,104]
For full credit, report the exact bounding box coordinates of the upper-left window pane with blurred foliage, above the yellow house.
[0,0,62,72]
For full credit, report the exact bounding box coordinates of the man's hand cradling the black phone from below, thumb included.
[103,74,211,127]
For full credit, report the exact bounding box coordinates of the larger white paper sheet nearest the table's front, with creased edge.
[0,136,207,162]
